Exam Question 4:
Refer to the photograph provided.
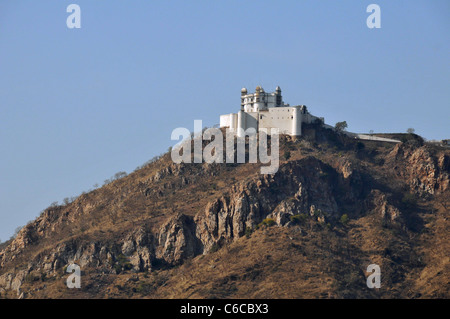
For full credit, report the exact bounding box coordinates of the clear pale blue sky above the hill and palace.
[0,0,450,241]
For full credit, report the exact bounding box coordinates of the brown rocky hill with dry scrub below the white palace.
[0,128,450,298]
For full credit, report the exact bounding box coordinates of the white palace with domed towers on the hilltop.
[220,86,324,137]
